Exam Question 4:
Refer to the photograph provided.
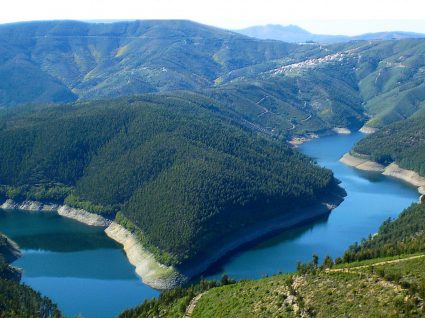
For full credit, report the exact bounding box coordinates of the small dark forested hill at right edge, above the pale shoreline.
[353,113,425,176]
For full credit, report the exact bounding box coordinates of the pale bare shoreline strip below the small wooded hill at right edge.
[339,153,425,201]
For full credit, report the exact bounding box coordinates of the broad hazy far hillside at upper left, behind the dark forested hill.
[0,20,294,106]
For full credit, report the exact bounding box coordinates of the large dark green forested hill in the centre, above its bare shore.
[0,95,337,263]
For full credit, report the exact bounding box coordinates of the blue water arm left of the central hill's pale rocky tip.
[0,210,159,318]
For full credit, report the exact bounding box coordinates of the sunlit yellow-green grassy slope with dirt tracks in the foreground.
[120,257,425,318]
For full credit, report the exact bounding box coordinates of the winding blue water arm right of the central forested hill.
[206,133,418,279]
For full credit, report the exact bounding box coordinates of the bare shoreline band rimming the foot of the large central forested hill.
[0,194,344,290]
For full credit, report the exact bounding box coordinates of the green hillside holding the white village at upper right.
[222,39,425,127]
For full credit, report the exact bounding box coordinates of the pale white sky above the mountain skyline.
[0,0,425,35]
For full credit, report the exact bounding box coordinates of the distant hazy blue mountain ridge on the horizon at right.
[235,24,425,43]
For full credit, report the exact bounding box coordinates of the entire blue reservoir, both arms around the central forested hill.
[0,133,418,318]
